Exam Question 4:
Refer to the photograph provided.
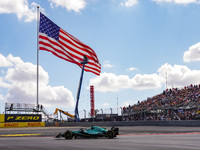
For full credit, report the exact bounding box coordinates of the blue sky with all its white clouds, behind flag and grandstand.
[0,0,200,117]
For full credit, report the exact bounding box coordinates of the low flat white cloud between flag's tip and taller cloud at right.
[90,73,163,92]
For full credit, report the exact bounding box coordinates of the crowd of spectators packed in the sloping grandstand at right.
[122,84,200,120]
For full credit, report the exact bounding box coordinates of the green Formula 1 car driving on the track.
[55,126,119,140]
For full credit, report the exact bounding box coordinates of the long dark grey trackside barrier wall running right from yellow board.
[45,120,200,127]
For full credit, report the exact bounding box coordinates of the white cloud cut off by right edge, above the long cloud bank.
[183,42,200,62]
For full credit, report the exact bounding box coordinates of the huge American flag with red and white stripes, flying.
[39,12,101,75]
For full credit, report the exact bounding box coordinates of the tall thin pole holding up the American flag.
[36,6,40,111]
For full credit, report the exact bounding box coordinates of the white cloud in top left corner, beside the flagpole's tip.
[0,0,44,22]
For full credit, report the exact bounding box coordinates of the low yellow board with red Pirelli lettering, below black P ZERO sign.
[0,122,45,128]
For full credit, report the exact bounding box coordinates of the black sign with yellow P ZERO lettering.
[5,114,42,122]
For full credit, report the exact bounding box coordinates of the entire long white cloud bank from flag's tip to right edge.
[90,63,200,92]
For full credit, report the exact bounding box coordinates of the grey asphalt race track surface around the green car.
[0,126,200,150]
